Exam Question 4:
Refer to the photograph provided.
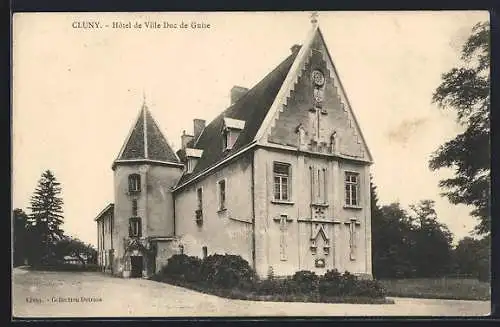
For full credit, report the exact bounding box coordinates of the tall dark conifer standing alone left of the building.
[29,170,64,264]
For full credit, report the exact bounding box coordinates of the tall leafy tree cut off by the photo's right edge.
[429,22,491,234]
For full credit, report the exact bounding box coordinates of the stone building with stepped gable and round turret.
[96,18,372,277]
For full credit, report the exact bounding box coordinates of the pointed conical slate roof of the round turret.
[116,105,180,163]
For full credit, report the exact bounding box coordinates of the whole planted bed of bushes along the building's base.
[151,254,392,303]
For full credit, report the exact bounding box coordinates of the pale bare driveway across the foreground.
[12,268,491,317]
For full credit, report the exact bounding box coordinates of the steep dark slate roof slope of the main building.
[177,51,298,185]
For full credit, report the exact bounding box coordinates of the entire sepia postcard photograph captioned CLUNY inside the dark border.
[11,11,491,319]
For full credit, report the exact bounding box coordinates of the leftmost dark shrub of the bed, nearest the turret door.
[158,254,201,282]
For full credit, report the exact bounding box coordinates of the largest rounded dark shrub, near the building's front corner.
[200,254,255,289]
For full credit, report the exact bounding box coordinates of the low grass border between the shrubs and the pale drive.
[148,277,394,304]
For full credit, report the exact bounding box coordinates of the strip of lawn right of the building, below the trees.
[380,278,491,301]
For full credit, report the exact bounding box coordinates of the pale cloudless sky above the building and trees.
[12,11,489,245]
